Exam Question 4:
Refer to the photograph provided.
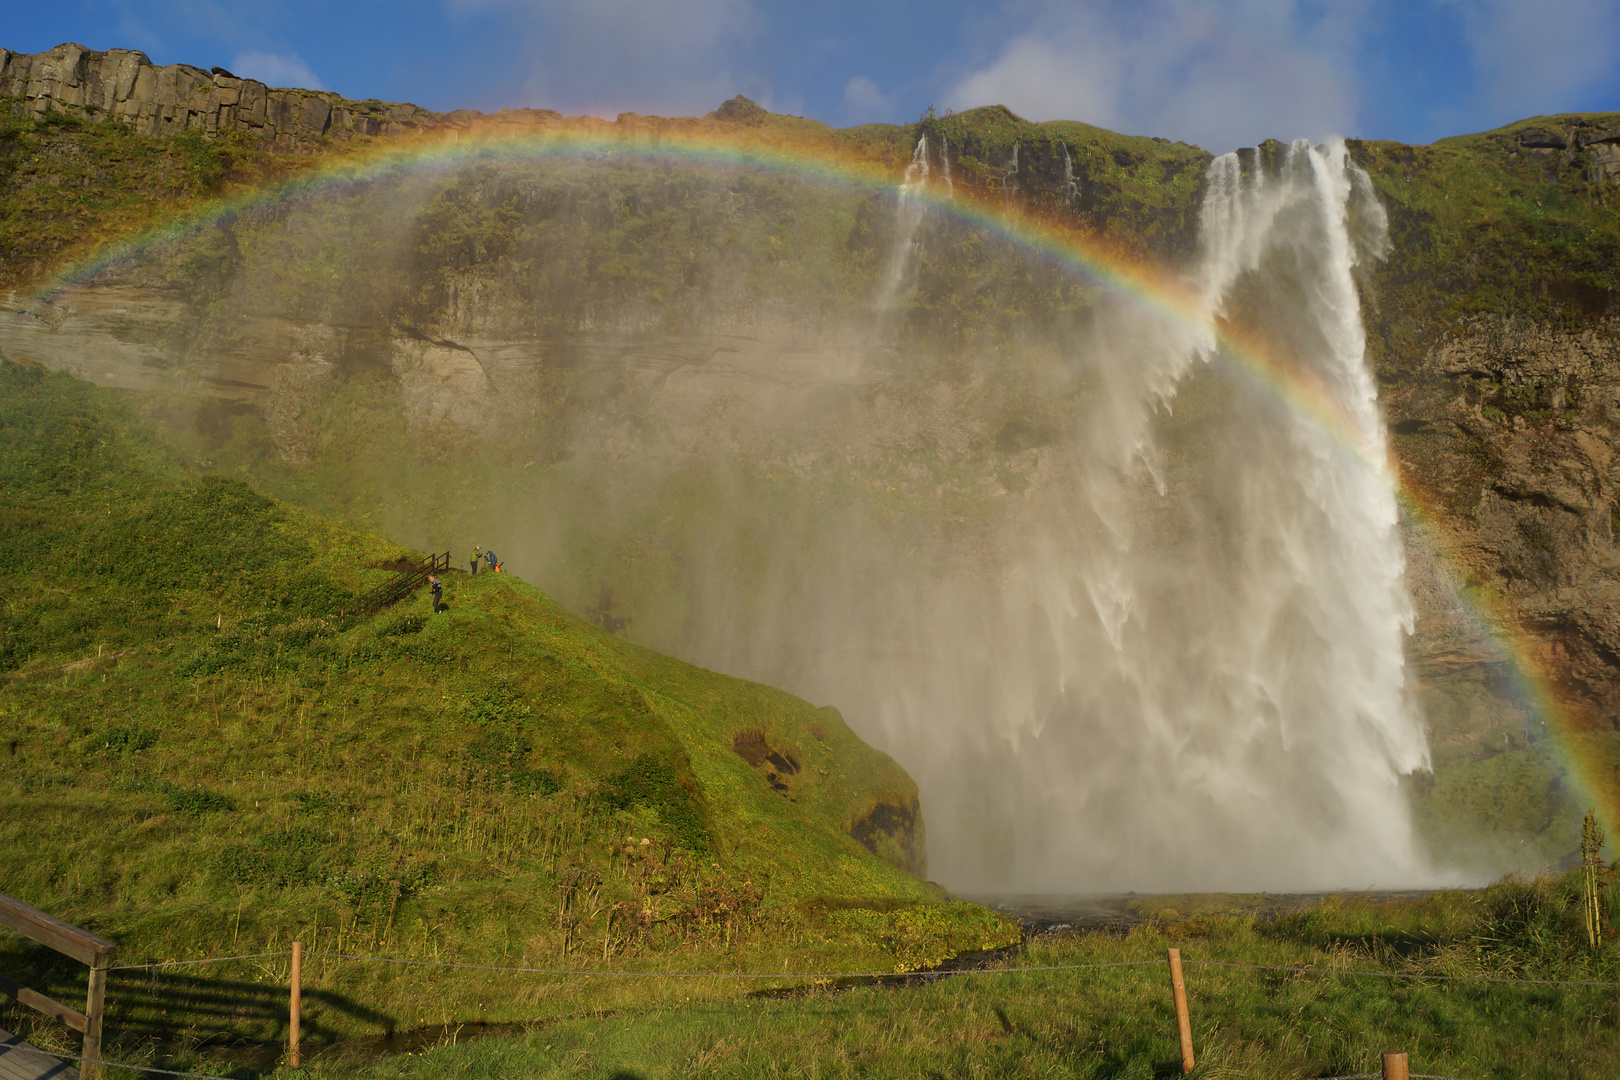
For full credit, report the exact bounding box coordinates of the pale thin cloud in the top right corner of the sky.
[1442,0,1620,120]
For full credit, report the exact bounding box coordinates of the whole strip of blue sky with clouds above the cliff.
[0,0,1620,151]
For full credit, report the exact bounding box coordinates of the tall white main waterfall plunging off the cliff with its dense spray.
[842,141,1429,891]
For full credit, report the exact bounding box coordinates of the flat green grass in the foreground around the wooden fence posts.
[41,876,1620,1080]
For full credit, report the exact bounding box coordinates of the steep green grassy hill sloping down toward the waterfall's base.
[0,361,1017,1062]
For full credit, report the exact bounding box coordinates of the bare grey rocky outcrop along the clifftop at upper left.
[0,44,562,151]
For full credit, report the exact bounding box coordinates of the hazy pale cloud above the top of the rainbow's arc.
[446,0,766,117]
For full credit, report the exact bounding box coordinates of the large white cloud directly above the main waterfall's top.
[946,0,1369,152]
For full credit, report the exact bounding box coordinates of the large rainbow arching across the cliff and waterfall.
[41,121,1620,827]
